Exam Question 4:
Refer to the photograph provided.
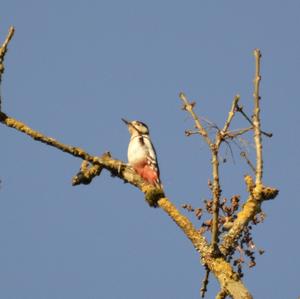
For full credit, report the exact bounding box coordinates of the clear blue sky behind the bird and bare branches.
[0,0,300,299]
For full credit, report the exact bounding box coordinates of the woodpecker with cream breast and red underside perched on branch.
[122,118,163,189]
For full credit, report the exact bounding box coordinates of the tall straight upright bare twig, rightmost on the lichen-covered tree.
[252,49,263,185]
